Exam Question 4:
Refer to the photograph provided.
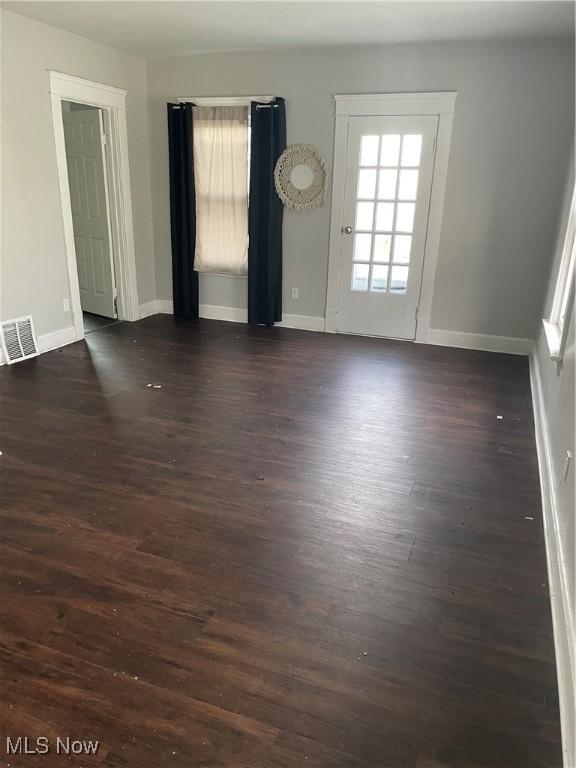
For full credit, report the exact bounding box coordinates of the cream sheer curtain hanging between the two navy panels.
[193,107,249,275]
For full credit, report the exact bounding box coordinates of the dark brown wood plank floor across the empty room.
[0,316,561,768]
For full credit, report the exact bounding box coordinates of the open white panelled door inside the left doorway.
[62,109,116,317]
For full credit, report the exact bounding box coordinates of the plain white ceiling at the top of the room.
[2,0,574,58]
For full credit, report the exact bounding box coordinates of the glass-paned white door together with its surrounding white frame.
[325,92,457,342]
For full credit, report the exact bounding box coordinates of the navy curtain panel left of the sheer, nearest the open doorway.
[168,104,198,319]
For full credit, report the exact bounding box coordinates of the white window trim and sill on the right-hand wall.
[542,185,576,362]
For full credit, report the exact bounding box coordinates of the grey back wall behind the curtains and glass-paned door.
[147,41,574,338]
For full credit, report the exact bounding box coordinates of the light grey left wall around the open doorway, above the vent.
[0,11,156,335]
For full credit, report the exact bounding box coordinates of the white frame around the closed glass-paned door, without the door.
[325,91,458,343]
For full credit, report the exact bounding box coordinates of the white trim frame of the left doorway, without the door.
[49,71,139,341]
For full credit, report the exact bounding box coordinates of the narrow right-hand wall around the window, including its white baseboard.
[532,156,576,766]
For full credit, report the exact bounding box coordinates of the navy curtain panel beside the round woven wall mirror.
[248,98,286,325]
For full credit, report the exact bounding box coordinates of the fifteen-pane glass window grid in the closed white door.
[352,134,422,293]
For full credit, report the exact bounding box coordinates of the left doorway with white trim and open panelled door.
[50,72,139,340]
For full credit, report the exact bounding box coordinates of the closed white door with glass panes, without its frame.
[337,115,438,339]
